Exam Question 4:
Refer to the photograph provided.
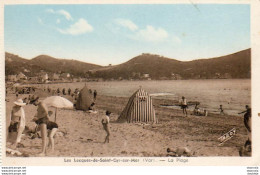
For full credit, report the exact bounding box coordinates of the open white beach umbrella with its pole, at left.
[42,96,73,122]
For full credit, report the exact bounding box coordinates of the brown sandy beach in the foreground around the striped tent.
[6,89,247,157]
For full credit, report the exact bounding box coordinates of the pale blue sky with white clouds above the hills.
[4,4,250,66]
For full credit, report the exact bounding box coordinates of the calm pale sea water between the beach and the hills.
[41,79,251,115]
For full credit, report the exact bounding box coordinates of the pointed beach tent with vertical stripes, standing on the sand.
[118,88,157,123]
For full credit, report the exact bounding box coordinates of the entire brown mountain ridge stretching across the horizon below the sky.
[5,48,251,80]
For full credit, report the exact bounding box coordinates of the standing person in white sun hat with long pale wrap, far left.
[7,99,26,149]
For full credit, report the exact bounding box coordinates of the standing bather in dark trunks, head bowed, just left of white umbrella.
[33,101,49,156]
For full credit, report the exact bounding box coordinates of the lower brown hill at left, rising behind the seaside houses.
[5,53,102,76]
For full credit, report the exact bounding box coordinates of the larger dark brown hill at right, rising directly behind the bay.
[90,49,251,79]
